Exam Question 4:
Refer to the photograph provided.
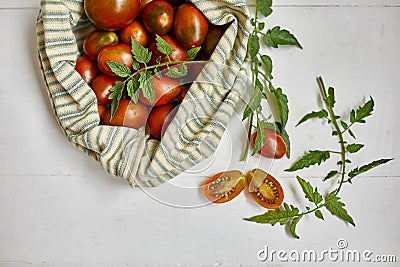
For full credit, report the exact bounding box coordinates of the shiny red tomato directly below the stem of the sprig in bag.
[139,76,181,106]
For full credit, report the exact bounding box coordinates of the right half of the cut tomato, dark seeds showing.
[246,169,284,209]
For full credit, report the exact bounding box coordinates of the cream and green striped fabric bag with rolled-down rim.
[37,0,249,186]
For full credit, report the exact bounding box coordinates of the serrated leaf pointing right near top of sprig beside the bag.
[263,26,303,48]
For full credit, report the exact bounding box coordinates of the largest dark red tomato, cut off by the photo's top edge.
[84,0,140,30]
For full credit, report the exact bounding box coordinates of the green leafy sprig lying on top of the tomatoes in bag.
[107,35,204,118]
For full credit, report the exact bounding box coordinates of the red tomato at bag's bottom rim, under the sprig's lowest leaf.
[101,99,148,129]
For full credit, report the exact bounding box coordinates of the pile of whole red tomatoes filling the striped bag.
[75,0,225,139]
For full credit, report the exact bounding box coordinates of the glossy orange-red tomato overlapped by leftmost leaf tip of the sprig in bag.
[97,44,133,77]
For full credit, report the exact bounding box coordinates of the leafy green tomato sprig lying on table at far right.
[245,77,393,238]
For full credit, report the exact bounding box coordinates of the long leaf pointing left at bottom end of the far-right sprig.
[245,205,299,225]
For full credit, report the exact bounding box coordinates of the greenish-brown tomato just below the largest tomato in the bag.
[83,30,118,60]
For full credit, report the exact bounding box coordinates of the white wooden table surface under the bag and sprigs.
[0,0,400,267]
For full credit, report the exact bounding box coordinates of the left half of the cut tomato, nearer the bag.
[204,171,246,203]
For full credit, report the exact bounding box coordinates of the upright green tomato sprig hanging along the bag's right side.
[242,0,302,160]
